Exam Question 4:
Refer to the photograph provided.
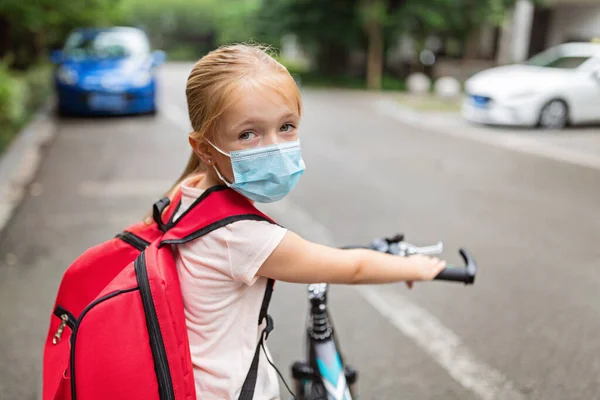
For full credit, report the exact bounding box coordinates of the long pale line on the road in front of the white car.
[375,100,600,169]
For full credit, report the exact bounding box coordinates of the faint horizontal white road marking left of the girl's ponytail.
[77,179,173,199]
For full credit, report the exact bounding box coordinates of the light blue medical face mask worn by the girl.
[208,140,306,203]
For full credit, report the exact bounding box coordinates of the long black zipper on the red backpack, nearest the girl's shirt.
[133,253,175,400]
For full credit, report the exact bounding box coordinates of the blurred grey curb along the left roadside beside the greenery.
[0,100,57,232]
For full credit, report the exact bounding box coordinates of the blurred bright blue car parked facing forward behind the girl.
[51,27,166,115]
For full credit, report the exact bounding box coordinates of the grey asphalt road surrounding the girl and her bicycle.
[0,64,600,400]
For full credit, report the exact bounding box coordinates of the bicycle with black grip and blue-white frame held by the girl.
[291,234,477,400]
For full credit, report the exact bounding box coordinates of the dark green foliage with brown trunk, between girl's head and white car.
[253,0,524,88]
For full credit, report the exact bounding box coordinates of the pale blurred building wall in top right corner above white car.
[548,5,600,47]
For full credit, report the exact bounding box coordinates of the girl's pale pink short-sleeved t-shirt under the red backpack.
[174,181,286,400]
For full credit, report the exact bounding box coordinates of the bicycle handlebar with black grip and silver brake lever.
[343,234,477,285]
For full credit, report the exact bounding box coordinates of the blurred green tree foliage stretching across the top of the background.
[0,0,524,86]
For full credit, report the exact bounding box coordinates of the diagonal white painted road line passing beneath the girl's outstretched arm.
[259,198,525,400]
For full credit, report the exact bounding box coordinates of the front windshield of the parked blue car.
[64,30,150,58]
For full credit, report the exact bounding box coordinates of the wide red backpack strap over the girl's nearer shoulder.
[159,186,275,247]
